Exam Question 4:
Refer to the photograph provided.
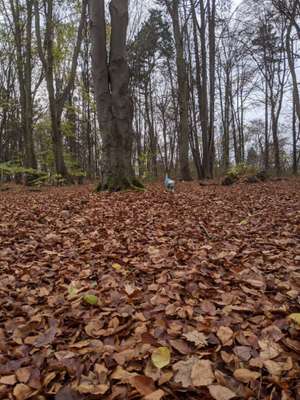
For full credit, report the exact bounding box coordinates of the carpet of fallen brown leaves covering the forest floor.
[0,180,300,400]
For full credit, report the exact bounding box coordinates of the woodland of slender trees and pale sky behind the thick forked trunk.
[0,0,300,182]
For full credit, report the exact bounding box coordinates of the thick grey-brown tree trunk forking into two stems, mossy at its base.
[89,0,141,191]
